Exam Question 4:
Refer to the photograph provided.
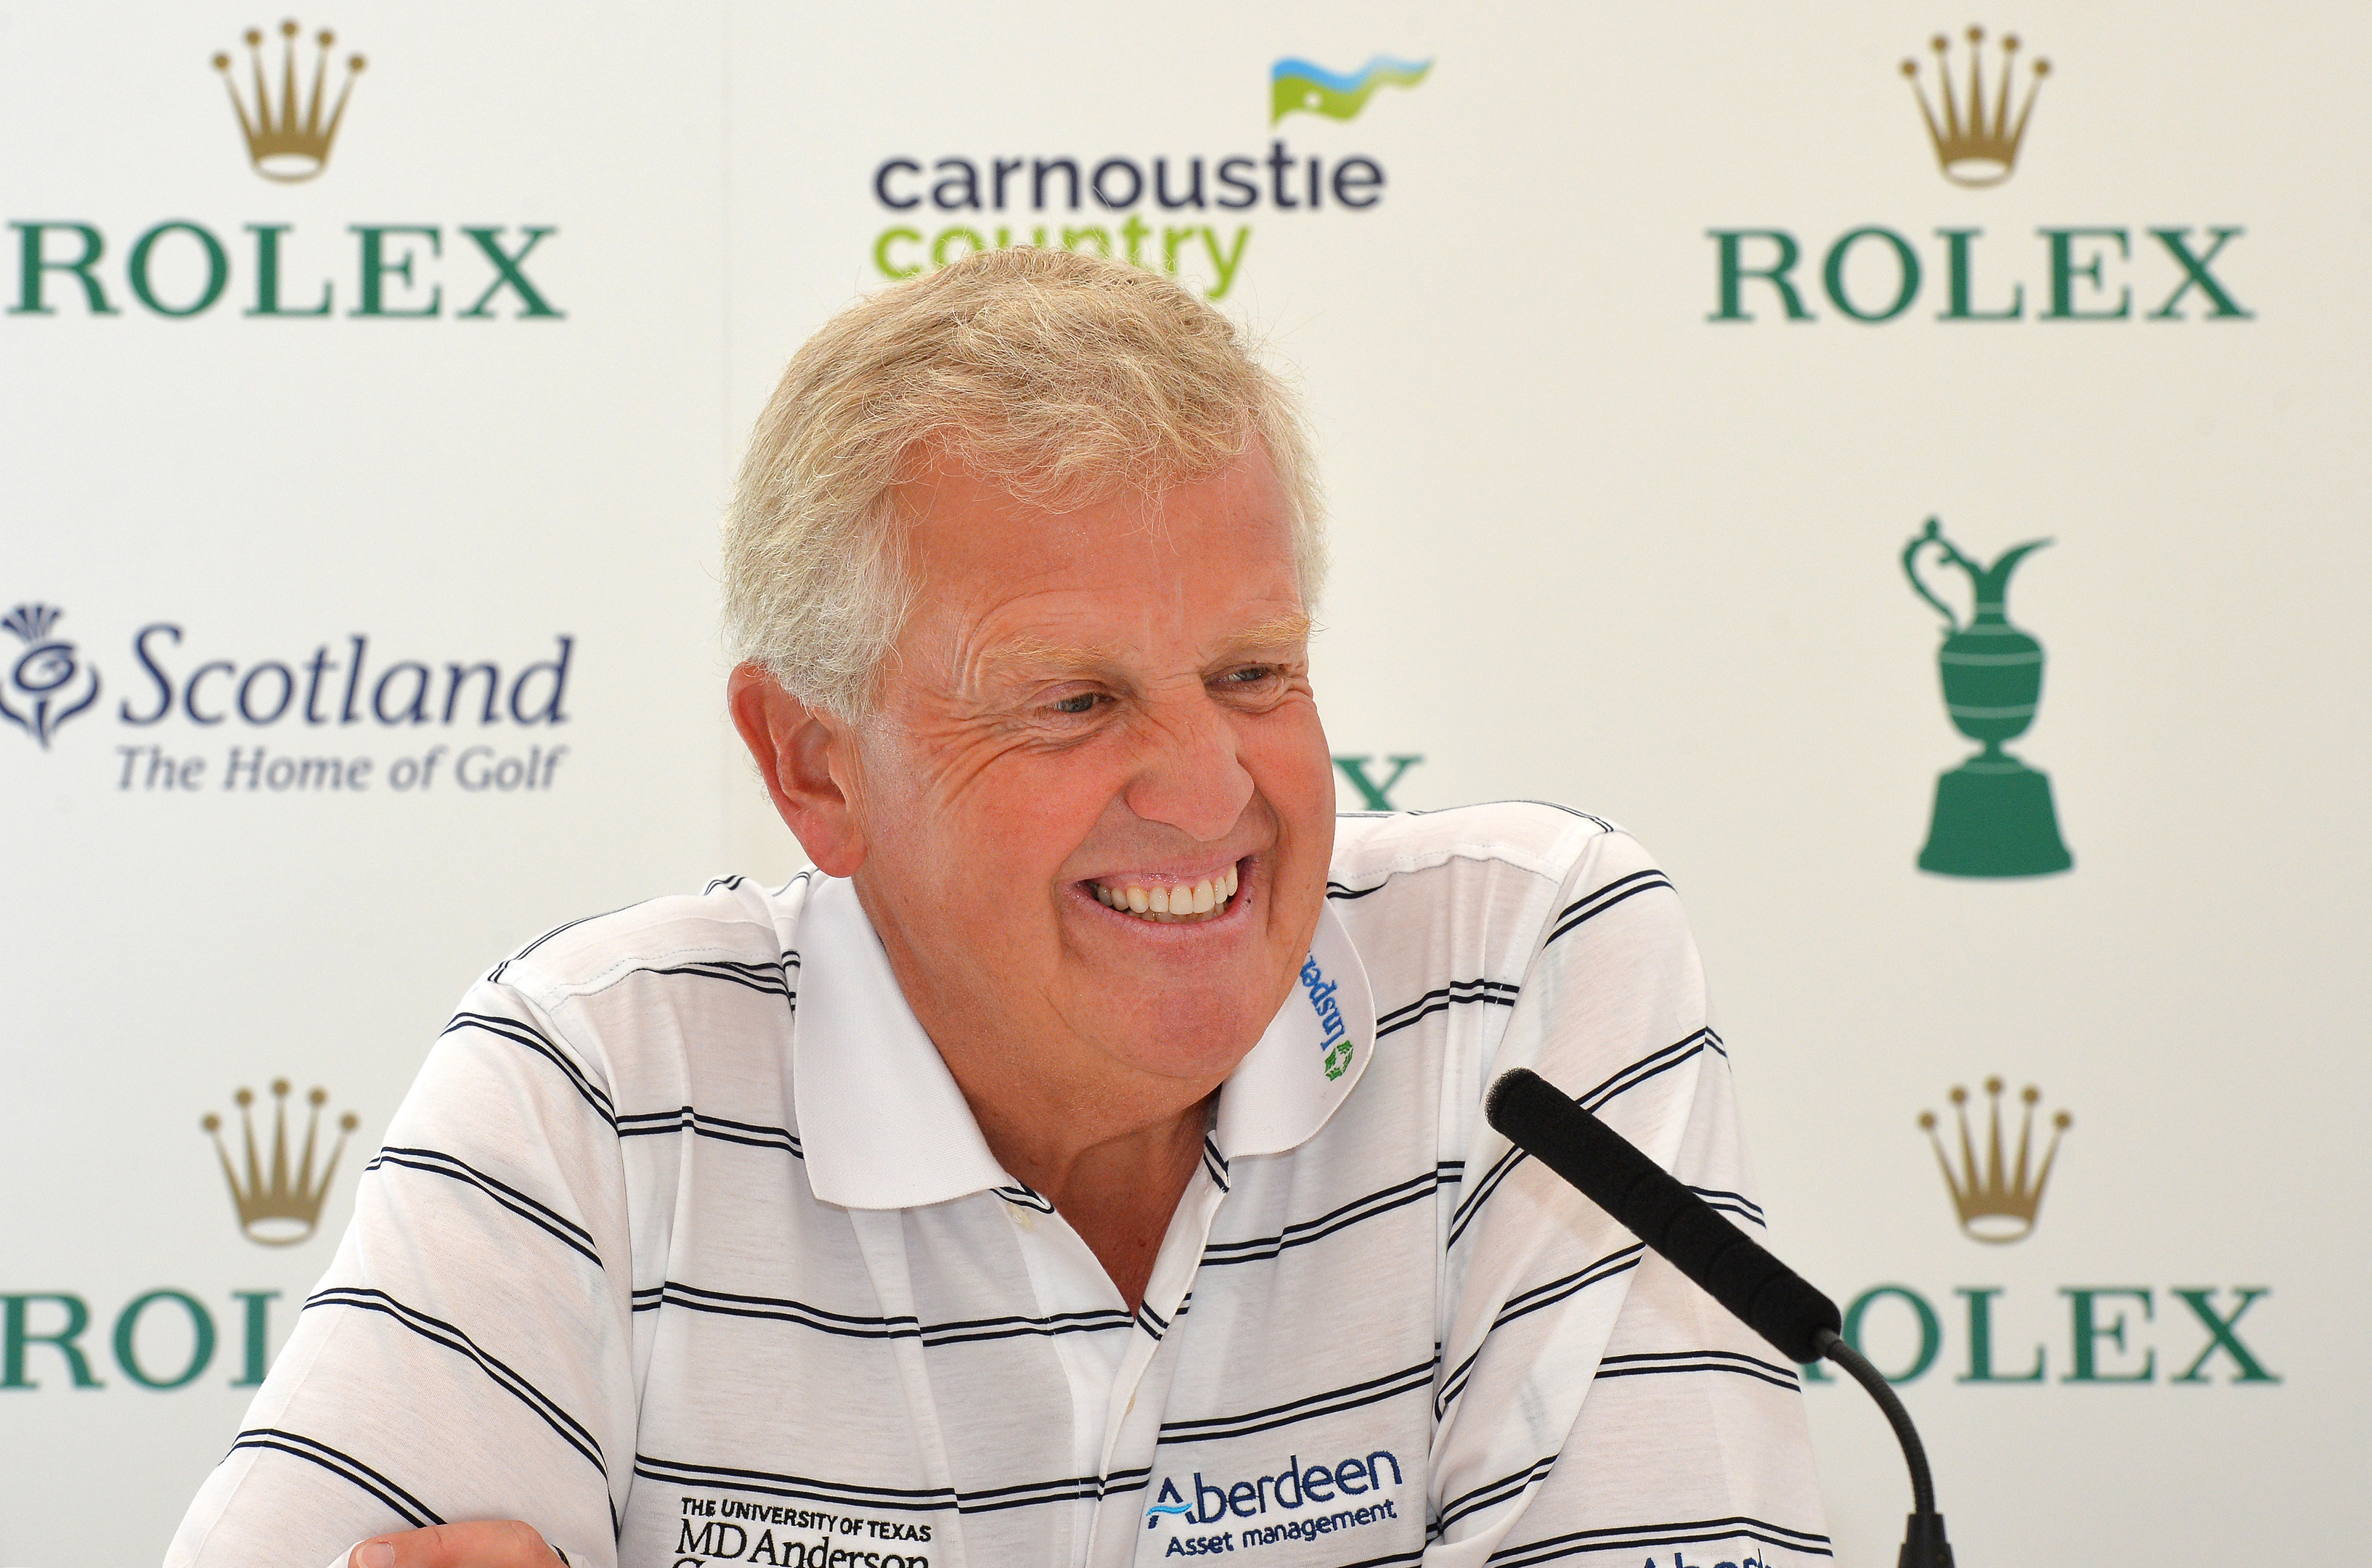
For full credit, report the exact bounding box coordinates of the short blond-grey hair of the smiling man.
[723,247,1326,719]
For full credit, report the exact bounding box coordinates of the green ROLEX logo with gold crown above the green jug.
[1705,26,2254,325]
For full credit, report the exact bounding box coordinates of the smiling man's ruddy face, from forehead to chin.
[849,446,1335,1093]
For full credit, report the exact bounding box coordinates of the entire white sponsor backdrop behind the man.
[0,0,2372,1568]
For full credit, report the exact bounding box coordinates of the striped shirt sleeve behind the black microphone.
[1423,833,1829,1568]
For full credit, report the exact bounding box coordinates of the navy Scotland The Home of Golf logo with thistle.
[0,603,576,795]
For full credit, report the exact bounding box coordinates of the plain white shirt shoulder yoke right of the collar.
[1326,799,1644,902]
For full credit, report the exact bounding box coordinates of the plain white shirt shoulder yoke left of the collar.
[486,873,811,1006]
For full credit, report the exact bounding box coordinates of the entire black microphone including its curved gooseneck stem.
[1483,1067,1952,1568]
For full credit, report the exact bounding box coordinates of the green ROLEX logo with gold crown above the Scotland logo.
[7,21,565,320]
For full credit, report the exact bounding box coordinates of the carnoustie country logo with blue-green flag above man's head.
[873,54,1432,299]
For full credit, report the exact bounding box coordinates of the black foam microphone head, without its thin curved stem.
[1483,1067,1843,1362]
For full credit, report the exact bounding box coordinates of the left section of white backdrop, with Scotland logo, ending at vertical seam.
[0,5,728,1568]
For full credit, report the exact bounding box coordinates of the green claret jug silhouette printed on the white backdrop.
[1902,517,2076,878]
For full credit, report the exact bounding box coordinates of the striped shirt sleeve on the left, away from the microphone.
[166,982,636,1568]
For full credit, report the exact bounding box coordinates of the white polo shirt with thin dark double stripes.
[166,804,1829,1568]
